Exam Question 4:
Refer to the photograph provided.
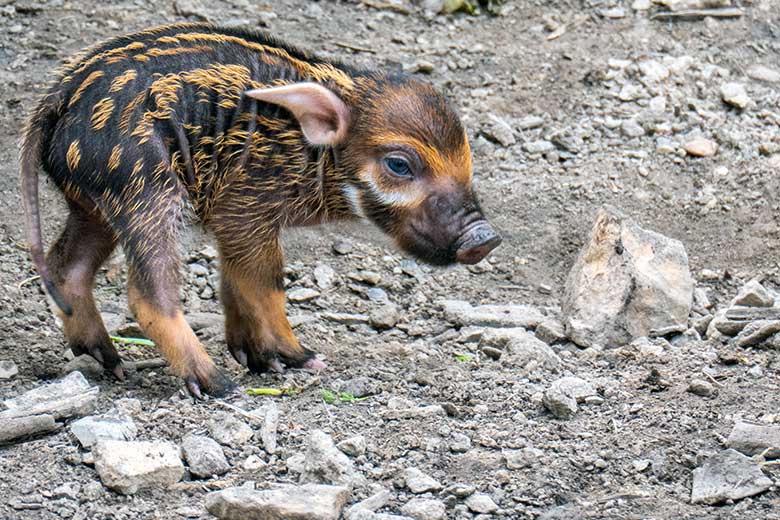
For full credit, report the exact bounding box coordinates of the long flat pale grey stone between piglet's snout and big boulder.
[439,300,544,329]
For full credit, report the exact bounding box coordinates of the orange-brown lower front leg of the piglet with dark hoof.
[221,244,325,373]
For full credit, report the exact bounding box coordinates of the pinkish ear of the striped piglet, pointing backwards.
[246,83,349,145]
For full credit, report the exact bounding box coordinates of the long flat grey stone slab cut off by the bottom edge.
[206,484,349,520]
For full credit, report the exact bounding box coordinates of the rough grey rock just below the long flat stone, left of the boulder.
[479,328,561,370]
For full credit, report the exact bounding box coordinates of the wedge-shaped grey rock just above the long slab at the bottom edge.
[301,430,361,487]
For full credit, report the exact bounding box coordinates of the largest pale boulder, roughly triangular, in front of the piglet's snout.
[562,206,694,346]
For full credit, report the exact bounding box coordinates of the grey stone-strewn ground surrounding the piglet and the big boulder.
[0,0,780,520]
